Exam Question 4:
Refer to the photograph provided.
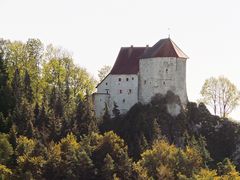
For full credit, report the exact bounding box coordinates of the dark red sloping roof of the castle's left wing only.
[110,47,148,74]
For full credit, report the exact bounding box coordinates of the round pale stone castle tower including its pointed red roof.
[138,38,188,105]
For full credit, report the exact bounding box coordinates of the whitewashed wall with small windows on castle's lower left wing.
[94,74,138,117]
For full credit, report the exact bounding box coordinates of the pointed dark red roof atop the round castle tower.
[141,38,188,59]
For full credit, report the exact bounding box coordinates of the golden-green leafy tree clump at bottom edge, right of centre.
[135,140,203,179]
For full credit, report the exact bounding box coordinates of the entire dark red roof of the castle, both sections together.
[110,38,188,74]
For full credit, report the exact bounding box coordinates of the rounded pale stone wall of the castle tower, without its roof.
[139,57,188,104]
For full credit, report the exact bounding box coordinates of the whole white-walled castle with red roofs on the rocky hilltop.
[93,38,188,117]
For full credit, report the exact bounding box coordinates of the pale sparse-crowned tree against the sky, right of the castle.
[201,76,240,117]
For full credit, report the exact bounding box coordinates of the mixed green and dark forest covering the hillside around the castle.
[0,39,240,180]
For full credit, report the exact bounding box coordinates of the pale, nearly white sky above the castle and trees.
[0,0,240,119]
